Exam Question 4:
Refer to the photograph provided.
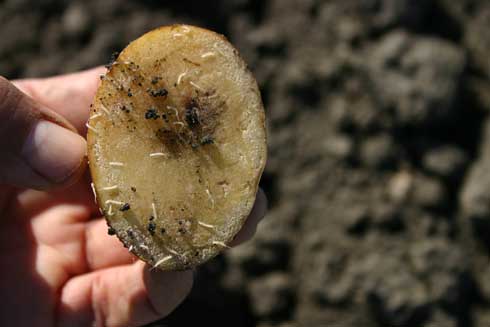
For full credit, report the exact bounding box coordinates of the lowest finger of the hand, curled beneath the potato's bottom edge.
[58,261,192,327]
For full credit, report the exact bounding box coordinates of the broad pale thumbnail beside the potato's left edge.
[22,120,87,183]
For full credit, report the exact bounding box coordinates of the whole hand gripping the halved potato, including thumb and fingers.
[0,68,267,327]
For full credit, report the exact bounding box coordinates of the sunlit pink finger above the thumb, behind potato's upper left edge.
[14,67,106,135]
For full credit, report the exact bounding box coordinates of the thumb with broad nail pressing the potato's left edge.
[0,76,86,190]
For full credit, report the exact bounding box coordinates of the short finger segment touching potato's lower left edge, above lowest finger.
[85,218,136,271]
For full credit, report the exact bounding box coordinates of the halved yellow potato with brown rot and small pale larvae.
[87,25,266,270]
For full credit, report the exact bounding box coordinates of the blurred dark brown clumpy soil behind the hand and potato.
[0,0,490,327]
